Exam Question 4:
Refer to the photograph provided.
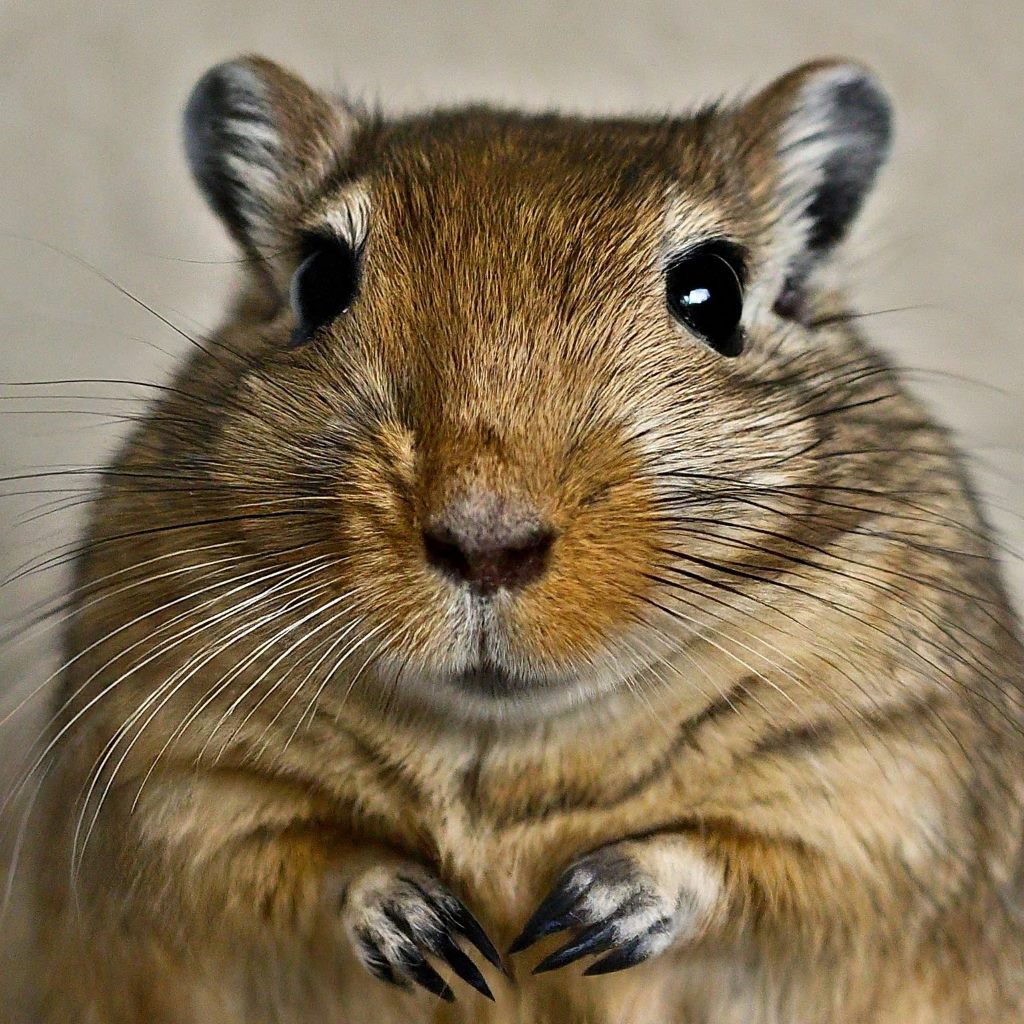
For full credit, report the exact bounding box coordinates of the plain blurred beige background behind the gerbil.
[0,0,1024,1007]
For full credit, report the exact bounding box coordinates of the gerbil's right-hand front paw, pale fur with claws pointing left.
[509,836,724,975]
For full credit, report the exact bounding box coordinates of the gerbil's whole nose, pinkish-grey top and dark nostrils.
[423,494,555,596]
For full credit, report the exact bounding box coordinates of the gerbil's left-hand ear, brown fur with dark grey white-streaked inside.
[184,56,355,268]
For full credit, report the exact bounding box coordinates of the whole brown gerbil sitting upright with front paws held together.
[19,57,1024,1024]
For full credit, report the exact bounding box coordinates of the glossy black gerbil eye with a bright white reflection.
[666,245,743,356]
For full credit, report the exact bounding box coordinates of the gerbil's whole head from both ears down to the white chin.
[178,59,888,717]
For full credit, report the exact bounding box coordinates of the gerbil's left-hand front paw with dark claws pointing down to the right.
[341,864,505,1002]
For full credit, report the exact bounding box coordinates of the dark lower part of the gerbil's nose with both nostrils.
[423,526,555,594]
